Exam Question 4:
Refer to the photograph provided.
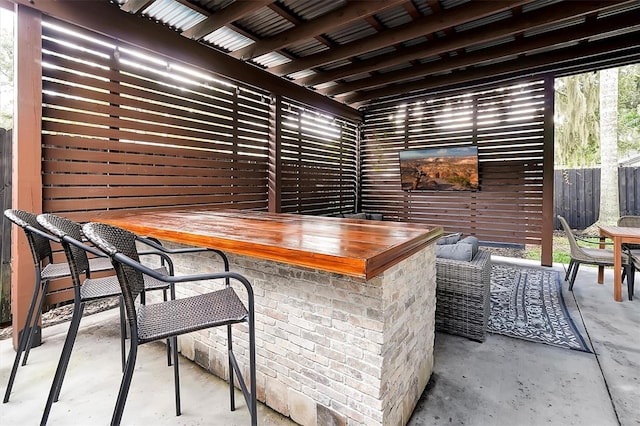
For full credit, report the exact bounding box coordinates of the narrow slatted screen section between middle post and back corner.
[281,99,358,214]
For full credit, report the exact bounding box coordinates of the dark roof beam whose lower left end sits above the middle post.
[269,0,530,75]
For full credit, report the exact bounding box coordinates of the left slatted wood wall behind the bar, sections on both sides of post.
[43,20,356,221]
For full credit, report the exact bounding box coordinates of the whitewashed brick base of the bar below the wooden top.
[143,243,436,426]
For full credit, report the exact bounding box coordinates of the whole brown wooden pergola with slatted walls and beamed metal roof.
[0,0,640,346]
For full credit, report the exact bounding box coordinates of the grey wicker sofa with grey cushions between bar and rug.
[436,249,491,342]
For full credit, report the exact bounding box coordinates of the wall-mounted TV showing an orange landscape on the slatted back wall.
[400,146,478,191]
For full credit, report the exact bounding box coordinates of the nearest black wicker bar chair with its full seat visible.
[83,223,257,425]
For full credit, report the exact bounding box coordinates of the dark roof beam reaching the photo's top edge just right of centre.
[231,0,407,60]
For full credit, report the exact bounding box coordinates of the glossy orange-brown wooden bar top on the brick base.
[97,209,442,279]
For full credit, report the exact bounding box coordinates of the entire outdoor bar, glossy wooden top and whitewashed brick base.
[99,209,442,426]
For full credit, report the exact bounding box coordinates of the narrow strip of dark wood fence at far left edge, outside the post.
[0,128,13,323]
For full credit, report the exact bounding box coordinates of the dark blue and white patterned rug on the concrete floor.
[488,263,591,352]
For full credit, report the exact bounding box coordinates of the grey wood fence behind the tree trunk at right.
[554,167,640,229]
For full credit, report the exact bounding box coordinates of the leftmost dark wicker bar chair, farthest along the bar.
[2,209,113,403]
